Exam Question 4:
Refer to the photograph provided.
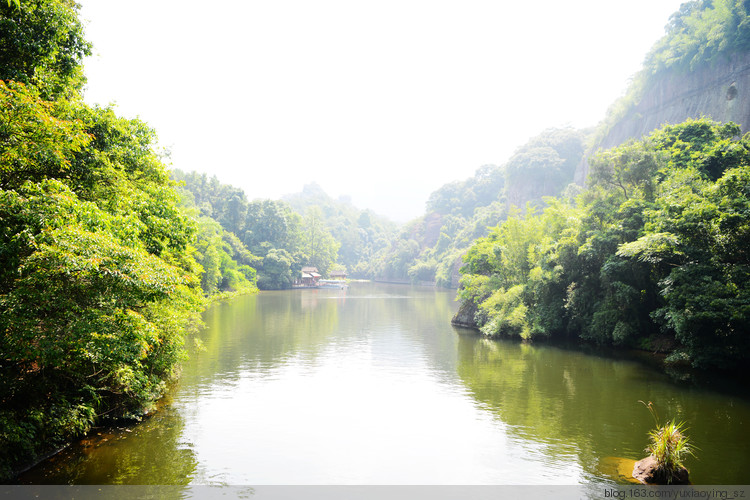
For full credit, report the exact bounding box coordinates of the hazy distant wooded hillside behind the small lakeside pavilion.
[172,174,395,290]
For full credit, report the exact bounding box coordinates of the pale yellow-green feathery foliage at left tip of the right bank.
[459,199,580,338]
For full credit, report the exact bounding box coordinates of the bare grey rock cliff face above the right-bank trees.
[575,53,750,184]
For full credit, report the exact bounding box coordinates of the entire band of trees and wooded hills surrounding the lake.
[0,0,750,486]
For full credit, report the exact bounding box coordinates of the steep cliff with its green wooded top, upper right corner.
[576,0,750,184]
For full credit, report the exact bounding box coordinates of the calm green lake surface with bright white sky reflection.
[20,284,750,485]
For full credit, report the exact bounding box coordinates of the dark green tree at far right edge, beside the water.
[618,158,750,367]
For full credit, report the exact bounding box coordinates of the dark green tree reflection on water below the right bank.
[457,336,750,484]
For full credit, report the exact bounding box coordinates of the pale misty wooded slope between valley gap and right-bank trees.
[378,128,586,287]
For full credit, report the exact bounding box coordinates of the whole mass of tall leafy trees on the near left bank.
[0,0,209,477]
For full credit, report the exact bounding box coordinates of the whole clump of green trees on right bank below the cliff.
[460,119,750,369]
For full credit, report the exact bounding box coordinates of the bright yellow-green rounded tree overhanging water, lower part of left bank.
[0,179,201,476]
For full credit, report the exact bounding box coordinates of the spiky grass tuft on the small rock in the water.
[641,401,695,483]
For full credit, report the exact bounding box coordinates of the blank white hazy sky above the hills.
[79,0,681,221]
